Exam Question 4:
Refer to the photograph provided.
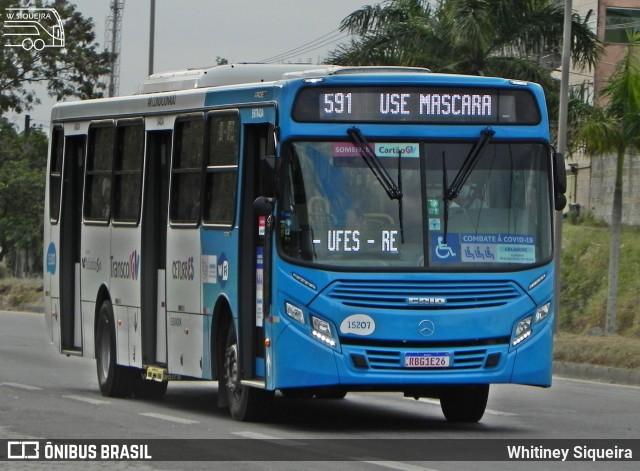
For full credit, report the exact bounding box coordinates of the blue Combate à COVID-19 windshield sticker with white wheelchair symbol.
[431,233,536,263]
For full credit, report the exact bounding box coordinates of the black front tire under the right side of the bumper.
[440,384,489,423]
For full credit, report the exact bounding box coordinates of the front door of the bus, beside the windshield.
[239,124,274,380]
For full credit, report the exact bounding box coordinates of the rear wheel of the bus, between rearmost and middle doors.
[96,299,135,397]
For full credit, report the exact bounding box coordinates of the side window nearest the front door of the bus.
[203,111,240,226]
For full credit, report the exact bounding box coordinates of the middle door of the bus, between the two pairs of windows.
[140,131,172,365]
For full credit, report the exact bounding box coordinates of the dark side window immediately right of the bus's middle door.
[169,114,204,225]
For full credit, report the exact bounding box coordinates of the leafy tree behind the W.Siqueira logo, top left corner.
[0,0,113,116]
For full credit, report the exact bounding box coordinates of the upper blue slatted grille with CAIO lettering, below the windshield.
[327,281,521,310]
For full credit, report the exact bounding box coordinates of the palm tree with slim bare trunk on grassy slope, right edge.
[576,33,640,334]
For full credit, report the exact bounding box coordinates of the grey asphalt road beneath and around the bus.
[0,312,640,471]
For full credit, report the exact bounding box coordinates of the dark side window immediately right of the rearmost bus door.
[84,121,115,222]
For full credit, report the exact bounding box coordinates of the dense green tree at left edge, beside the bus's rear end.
[0,118,47,275]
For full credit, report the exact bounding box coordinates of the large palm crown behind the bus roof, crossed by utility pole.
[327,0,601,90]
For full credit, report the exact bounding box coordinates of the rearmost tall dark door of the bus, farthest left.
[54,136,86,352]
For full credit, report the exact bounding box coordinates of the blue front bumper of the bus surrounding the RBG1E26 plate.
[269,323,553,391]
